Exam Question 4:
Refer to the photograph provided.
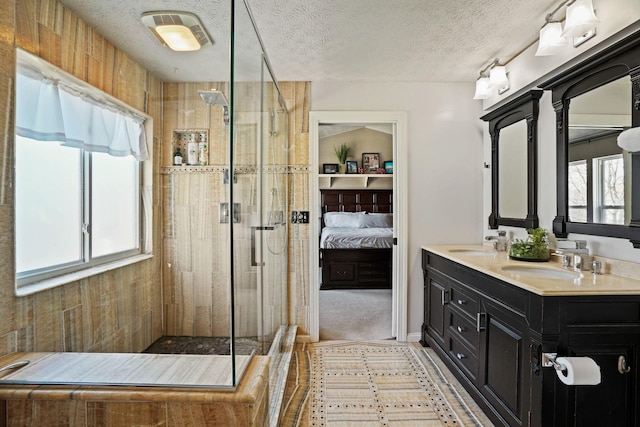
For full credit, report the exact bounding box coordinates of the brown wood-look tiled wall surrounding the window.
[0,0,162,354]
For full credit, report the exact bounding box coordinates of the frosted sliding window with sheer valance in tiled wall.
[15,51,150,288]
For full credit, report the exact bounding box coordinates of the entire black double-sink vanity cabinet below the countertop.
[421,250,640,427]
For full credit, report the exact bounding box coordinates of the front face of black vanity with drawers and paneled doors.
[422,252,530,426]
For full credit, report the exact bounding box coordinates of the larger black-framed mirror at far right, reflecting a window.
[540,33,640,248]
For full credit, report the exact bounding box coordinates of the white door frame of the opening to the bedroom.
[308,111,408,342]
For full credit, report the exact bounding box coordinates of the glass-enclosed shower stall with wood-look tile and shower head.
[156,1,291,387]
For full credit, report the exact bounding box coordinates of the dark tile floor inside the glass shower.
[143,336,271,355]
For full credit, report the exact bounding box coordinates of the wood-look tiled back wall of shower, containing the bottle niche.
[162,82,310,336]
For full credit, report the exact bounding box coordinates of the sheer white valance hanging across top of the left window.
[16,51,149,161]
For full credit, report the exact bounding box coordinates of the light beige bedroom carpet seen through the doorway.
[319,289,392,341]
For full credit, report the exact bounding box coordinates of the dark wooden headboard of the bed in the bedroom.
[320,190,393,213]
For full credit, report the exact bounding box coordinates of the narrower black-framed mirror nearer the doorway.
[481,90,542,229]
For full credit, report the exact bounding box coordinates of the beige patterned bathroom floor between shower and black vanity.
[278,341,493,427]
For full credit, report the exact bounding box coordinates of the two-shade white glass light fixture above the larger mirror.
[536,0,598,56]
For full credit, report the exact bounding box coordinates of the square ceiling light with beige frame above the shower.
[140,11,213,52]
